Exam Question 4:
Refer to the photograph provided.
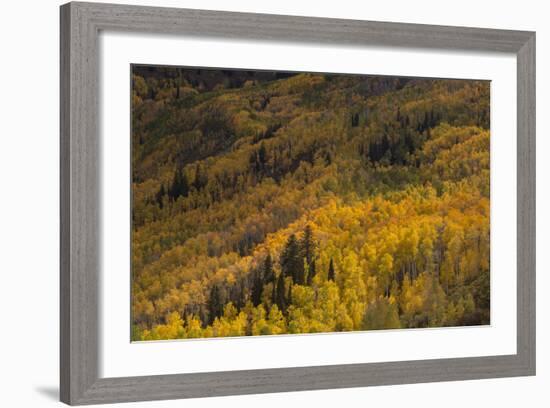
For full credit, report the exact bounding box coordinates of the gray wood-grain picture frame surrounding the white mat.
[60,3,535,405]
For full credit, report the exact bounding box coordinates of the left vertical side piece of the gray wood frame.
[60,3,100,405]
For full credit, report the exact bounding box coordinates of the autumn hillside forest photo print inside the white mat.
[131,65,490,341]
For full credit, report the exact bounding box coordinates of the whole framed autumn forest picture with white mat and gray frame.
[61,3,535,405]
